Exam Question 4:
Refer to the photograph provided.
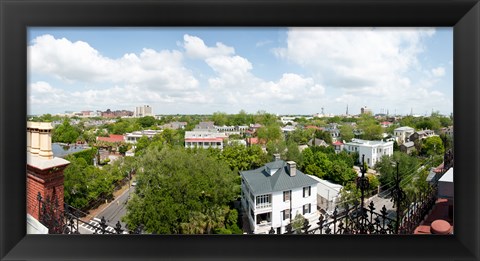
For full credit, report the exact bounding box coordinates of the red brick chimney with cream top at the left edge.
[27,122,70,220]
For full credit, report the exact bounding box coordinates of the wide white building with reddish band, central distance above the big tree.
[185,130,227,149]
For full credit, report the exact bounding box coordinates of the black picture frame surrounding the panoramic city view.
[0,0,480,260]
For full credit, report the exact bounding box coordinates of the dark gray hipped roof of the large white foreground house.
[240,160,318,195]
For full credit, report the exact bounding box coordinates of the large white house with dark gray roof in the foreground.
[240,159,319,234]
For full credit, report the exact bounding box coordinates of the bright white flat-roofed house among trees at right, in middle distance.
[344,139,393,167]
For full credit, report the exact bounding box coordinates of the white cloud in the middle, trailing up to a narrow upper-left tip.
[184,36,325,111]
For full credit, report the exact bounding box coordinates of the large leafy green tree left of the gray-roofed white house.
[123,147,240,234]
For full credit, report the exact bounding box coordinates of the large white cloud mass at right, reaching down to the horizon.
[272,28,451,113]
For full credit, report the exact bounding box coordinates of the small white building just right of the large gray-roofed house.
[309,175,343,214]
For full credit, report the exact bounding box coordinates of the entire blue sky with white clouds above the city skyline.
[27,27,453,115]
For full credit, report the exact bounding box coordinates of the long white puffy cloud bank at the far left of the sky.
[28,35,198,91]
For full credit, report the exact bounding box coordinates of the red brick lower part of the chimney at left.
[26,165,67,220]
